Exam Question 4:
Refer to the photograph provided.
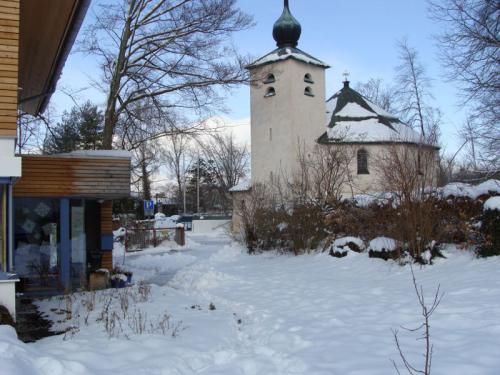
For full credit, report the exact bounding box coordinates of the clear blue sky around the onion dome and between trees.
[52,0,464,152]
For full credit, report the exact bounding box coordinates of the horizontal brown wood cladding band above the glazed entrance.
[14,155,130,200]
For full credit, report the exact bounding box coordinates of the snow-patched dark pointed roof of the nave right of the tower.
[318,81,434,146]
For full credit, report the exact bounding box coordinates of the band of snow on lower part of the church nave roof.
[327,118,420,143]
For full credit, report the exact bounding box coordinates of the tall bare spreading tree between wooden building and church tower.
[80,0,252,149]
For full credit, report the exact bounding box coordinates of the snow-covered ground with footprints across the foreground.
[0,235,500,375]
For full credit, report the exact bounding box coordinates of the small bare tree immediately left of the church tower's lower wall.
[200,133,249,209]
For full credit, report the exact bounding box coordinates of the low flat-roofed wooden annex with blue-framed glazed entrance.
[13,151,130,293]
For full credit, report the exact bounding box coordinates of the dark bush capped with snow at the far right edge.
[477,196,500,257]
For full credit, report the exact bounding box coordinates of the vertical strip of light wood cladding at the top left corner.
[0,0,20,137]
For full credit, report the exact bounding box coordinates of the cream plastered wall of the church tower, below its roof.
[250,59,326,183]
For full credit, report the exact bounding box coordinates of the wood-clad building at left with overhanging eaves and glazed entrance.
[0,0,130,296]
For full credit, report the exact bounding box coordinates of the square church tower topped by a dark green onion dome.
[247,0,329,184]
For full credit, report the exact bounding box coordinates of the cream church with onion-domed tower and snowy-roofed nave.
[231,0,438,229]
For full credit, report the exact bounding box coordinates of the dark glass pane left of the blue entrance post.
[14,198,61,292]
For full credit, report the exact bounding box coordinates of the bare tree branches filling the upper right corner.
[429,0,500,169]
